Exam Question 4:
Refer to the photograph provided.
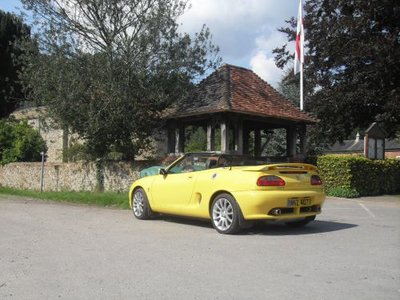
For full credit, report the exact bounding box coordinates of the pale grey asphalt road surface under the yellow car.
[0,196,400,300]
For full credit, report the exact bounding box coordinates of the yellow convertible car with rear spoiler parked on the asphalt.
[129,153,325,234]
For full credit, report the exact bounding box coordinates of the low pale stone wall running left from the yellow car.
[0,162,151,192]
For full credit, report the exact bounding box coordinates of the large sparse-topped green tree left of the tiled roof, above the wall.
[22,0,219,159]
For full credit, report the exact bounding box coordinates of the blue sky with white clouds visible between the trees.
[0,0,298,87]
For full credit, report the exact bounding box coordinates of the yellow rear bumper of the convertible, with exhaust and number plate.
[233,190,325,220]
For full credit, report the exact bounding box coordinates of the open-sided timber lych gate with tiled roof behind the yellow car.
[162,65,316,160]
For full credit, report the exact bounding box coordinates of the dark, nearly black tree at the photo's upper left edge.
[0,10,30,118]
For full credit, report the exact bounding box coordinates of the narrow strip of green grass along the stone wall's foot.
[0,187,129,209]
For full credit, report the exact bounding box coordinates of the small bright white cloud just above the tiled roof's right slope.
[250,51,283,87]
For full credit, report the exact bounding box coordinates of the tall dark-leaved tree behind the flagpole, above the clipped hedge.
[274,0,400,142]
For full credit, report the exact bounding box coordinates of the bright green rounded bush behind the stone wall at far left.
[0,120,47,165]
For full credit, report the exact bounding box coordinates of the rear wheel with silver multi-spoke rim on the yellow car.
[210,194,241,234]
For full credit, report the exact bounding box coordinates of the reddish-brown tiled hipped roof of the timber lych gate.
[169,65,316,123]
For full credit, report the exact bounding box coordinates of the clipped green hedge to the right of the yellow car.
[317,155,400,198]
